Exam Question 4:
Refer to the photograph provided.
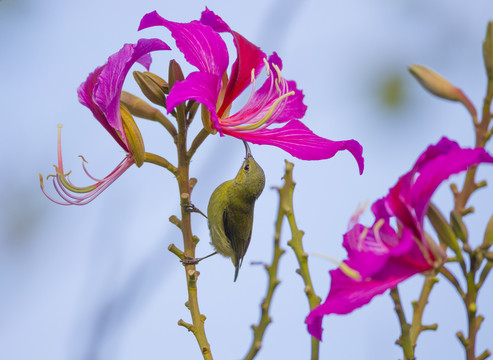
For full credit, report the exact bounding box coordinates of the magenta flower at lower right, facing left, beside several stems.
[306,138,493,340]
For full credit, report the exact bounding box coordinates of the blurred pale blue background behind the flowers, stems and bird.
[0,0,493,360]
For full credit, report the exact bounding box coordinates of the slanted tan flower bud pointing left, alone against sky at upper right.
[409,65,476,116]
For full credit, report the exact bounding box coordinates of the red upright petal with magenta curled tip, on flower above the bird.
[200,8,266,116]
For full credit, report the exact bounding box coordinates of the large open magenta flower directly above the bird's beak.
[139,9,364,173]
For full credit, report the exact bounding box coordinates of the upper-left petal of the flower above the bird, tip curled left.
[139,11,229,77]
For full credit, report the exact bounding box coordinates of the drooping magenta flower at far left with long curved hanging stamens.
[40,39,170,205]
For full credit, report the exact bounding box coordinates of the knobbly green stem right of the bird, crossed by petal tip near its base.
[281,161,321,360]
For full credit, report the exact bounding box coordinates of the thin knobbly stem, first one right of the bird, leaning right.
[245,184,285,360]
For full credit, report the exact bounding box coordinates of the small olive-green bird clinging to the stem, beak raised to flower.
[207,140,265,281]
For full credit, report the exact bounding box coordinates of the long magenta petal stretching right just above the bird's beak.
[224,120,364,174]
